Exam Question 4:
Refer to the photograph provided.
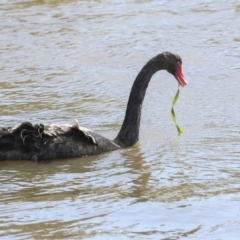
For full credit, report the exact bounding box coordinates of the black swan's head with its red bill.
[163,52,187,87]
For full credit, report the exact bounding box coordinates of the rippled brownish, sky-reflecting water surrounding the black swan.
[0,0,240,239]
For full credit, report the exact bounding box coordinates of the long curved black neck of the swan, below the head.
[114,54,166,147]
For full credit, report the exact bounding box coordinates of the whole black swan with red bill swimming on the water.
[0,52,187,161]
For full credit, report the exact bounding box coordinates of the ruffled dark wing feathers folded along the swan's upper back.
[0,120,98,152]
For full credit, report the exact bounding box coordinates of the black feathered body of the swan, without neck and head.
[0,120,119,161]
